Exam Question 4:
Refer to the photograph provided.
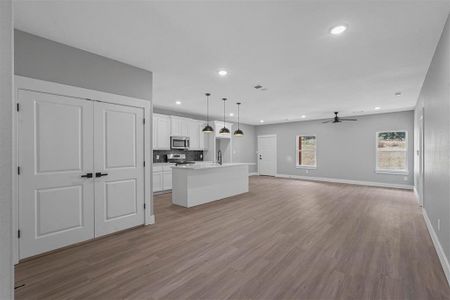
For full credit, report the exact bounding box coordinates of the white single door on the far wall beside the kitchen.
[258,135,277,176]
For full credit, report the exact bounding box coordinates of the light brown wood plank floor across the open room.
[16,177,450,299]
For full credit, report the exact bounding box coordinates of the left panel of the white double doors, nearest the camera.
[18,90,94,258]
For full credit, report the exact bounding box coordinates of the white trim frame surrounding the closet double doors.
[12,75,155,264]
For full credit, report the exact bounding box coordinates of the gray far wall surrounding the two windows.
[256,111,414,185]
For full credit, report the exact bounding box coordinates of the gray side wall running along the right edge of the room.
[416,15,450,258]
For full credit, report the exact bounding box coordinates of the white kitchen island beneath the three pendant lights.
[172,163,248,207]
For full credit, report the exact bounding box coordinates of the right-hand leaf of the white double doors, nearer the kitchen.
[94,102,144,237]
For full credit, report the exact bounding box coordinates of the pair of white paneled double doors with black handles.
[18,90,144,258]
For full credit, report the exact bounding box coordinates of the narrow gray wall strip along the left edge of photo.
[0,0,14,299]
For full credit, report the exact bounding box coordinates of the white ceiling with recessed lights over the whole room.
[15,0,450,124]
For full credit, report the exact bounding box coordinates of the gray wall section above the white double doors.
[14,30,152,100]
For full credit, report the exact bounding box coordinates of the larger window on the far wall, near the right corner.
[376,131,408,173]
